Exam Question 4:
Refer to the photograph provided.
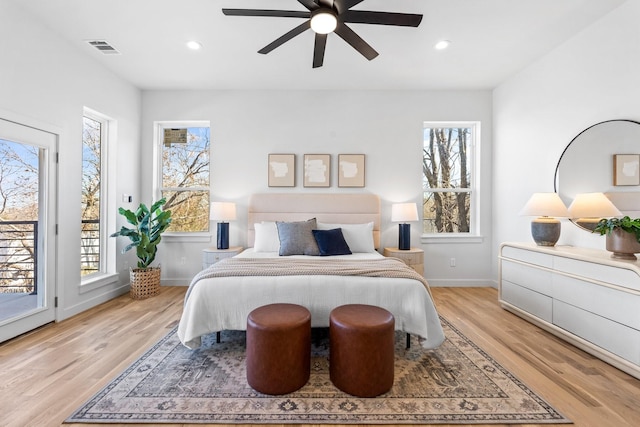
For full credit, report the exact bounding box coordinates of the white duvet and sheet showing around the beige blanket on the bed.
[178,249,444,348]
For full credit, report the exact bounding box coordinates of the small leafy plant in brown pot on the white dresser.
[593,216,640,260]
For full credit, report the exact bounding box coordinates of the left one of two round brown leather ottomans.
[247,304,311,394]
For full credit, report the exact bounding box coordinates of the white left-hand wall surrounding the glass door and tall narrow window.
[0,2,140,319]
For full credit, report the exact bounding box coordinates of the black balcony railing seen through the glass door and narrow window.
[0,219,100,294]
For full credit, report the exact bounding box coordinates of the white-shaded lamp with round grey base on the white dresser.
[520,193,569,246]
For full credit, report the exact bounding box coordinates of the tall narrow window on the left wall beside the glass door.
[80,110,109,276]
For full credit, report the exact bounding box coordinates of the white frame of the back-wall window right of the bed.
[420,120,484,243]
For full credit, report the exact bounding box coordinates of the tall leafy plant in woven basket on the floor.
[111,198,171,299]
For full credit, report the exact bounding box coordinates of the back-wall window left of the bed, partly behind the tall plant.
[157,122,210,233]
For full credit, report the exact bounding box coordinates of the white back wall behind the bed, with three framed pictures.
[142,91,492,285]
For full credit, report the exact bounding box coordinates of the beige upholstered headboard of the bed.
[247,193,380,248]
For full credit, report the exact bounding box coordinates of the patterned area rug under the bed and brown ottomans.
[67,319,570,424]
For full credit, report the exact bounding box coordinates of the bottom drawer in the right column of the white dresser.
[553,301,640,365]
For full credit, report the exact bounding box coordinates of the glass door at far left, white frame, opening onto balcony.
[0,119,57,342]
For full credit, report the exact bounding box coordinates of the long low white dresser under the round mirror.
[499,243,640,378]
